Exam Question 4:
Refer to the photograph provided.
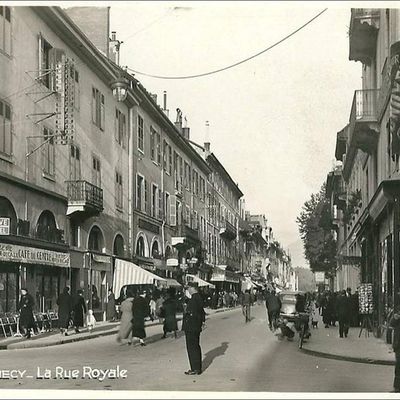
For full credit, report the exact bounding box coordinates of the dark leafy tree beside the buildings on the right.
[296,184,336,272]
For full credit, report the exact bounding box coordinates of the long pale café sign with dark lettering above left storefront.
[0,243,70,268]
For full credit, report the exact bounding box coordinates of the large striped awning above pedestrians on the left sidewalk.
[113,258,166,296]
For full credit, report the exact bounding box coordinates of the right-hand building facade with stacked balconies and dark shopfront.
[332,8,400,333]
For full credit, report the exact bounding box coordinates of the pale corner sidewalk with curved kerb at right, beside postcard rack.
[302,320,395,365]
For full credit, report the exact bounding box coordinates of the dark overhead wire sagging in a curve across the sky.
[127,8,328,80]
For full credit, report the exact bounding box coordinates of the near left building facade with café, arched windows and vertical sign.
[0,6,135,313]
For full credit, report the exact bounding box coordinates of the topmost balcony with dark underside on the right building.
[349,8,380,64]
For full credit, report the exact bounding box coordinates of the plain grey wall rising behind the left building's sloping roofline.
[64,7,110,57]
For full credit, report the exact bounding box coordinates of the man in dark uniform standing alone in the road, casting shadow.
[182,282,206,375]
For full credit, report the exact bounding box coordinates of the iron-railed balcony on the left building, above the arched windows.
[66,181,103,216]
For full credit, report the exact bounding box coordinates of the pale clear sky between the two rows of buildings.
[105,1,361,267]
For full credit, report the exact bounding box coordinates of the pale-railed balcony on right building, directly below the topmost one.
[343,89,379,181]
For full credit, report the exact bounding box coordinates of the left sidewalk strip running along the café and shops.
[0,307,237,350]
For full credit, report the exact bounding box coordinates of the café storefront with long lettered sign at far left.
[0,243,70,312]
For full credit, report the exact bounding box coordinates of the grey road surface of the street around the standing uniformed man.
[0,304,393,392]
